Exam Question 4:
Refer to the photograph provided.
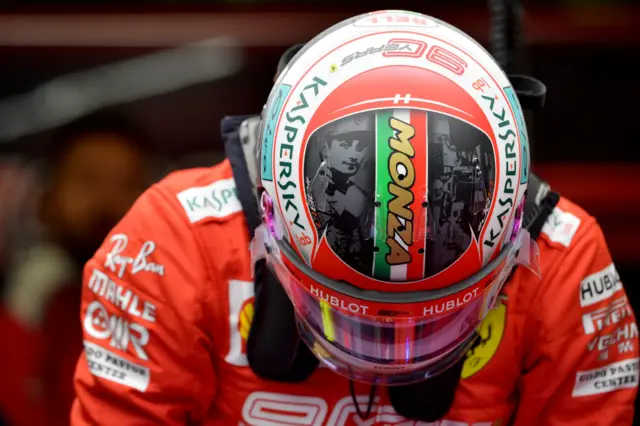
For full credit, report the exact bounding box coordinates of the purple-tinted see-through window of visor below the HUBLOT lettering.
[290,285,484,384]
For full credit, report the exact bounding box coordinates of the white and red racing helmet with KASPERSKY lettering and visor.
[252,11,537,385]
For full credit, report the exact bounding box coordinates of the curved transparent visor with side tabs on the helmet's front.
[252,221,537,385]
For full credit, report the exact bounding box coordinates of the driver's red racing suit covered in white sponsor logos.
[71,161,638,426]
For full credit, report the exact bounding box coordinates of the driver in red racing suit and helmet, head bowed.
[71,12,638,426]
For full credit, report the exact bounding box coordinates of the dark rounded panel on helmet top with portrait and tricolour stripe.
[304,108,495,281]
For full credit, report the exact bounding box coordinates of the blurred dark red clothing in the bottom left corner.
[0,286,82,426]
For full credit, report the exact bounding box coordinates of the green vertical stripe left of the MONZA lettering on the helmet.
[373,110,394,280]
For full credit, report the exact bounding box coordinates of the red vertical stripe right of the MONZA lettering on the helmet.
[407,110,428,281]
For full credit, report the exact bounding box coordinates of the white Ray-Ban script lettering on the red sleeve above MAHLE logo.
[104,234,164,278]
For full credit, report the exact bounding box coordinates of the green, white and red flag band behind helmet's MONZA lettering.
[373,109,428,281]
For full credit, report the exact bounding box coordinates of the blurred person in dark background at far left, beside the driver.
[0,112,148,426]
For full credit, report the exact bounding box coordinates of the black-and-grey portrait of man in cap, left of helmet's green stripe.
[304,113,376,274]
